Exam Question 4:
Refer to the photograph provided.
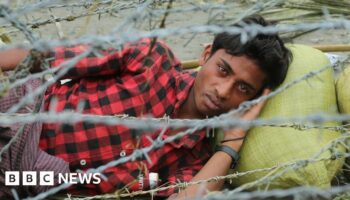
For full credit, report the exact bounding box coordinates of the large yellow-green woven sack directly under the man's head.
[226,45,345,189]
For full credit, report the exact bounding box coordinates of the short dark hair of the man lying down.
[211,15,292,89]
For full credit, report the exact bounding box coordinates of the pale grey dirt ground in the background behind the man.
[4,0,350,61]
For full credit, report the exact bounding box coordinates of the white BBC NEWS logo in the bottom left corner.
[5,171,101,186]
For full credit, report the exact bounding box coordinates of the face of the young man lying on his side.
[192,46,266,116]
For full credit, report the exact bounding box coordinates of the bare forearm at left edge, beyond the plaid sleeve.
[0,49,29,71]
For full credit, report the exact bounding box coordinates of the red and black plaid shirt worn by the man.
[40,39,210,195]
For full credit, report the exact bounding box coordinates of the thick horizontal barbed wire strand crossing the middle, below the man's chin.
[0,108,350,131]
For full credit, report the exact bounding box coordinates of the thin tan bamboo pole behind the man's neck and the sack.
[182,44,350,69]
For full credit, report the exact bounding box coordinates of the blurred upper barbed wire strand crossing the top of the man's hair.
[0,18,350,51]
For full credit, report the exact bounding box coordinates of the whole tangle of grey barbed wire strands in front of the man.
[0,0,350,199]
